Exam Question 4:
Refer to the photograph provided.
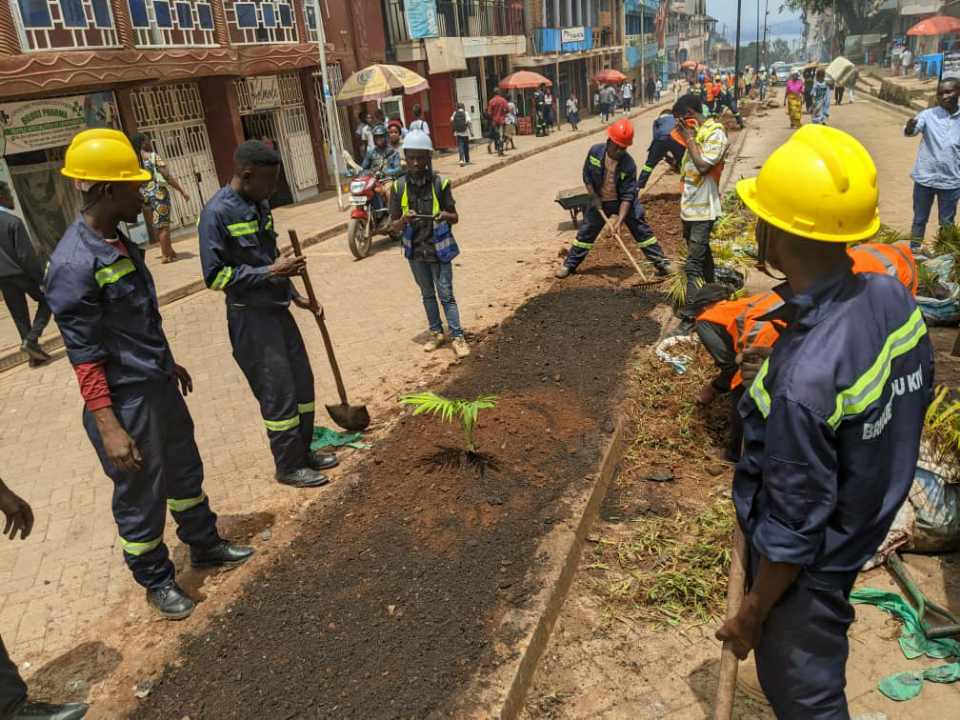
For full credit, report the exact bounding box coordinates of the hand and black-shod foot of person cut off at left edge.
[0,479,89,720]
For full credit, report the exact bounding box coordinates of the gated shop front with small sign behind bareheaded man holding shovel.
[235,73,318,207]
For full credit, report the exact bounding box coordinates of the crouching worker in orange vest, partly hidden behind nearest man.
[694,236,918,462]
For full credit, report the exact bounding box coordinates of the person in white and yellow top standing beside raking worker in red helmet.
[673,95,729,335]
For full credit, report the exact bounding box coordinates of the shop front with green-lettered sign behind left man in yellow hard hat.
[0,91,120,255]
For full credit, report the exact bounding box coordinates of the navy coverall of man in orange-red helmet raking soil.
[564,143,669,270]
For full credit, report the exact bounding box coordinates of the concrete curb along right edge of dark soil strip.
[464,421,627,720]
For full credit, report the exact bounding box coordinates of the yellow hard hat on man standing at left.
[60,128,153,183]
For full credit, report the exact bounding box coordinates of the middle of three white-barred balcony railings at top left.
[127,0,217,47]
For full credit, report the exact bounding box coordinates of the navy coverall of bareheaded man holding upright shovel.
[199,185,315,473]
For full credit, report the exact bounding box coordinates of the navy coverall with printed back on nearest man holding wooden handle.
[733,271,933,720]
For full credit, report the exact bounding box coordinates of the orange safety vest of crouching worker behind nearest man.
[697,242,918,390]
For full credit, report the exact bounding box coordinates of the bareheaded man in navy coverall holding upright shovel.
[199,139,340,488]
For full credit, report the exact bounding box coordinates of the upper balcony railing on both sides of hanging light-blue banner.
[386,0,526,44]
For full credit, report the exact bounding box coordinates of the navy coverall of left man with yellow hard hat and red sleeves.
[45,218,220,590]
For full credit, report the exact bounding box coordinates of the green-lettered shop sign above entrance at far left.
[0,91,120,156]
